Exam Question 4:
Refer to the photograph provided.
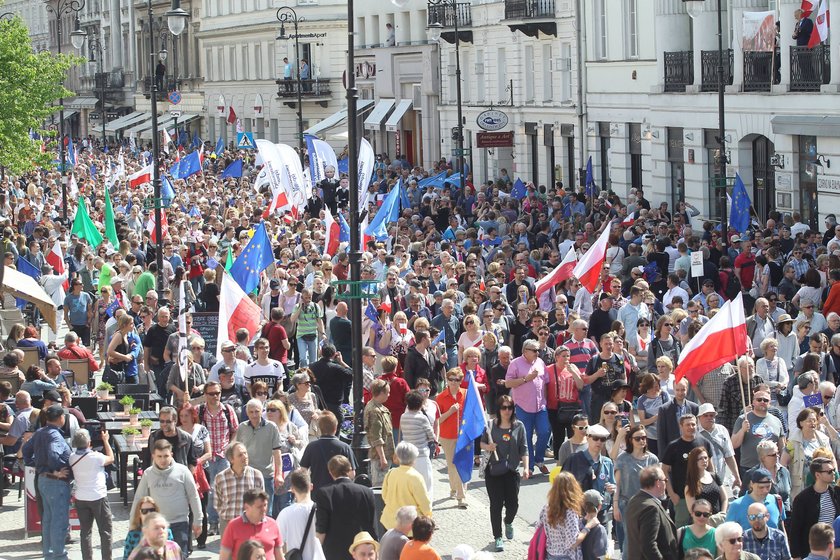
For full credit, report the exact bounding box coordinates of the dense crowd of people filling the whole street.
[0,136,840,560]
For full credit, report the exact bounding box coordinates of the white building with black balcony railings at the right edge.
[583,0,840,227]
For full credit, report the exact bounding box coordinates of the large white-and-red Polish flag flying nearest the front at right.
[674,294,748,383]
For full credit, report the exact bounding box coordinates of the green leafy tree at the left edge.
[0,17,83,174]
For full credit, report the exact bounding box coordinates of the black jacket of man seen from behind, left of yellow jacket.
[312,478,377,560]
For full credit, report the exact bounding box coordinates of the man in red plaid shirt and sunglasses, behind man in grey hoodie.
[198,381,239,535]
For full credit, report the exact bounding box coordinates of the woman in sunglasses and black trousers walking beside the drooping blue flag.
[481,395,531,552]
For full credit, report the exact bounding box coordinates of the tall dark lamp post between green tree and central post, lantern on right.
[146,0,189,298]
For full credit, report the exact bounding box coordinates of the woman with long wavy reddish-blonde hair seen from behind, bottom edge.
[536,472,598,560]
